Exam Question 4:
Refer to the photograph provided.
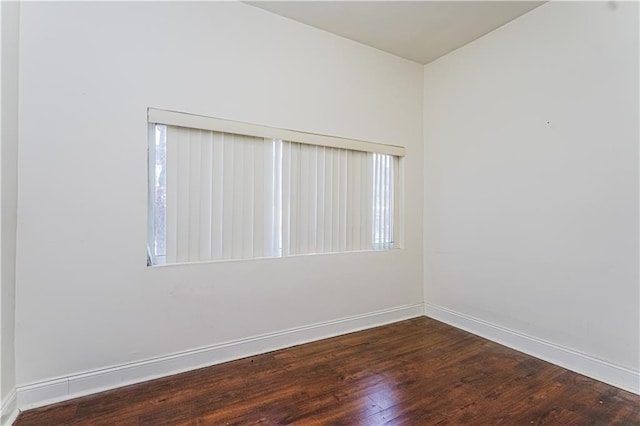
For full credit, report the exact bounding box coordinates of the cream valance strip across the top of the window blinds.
[147,108,405,157]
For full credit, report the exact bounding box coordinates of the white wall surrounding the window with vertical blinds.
[16,2,423,392]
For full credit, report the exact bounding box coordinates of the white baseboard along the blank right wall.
[424,303,640,395]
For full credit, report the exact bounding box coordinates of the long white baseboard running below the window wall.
[16,303,424,410]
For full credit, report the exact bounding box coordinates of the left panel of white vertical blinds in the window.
[166,126,276,263]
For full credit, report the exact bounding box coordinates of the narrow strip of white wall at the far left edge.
[0,2,20,424]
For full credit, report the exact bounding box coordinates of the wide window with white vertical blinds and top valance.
[147,109,404,265]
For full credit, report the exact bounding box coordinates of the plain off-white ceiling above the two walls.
[246,0,545,64]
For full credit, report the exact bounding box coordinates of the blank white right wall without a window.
[424,2,640,392]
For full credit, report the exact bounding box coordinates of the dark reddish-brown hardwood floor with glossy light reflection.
[15,317,640,426]
